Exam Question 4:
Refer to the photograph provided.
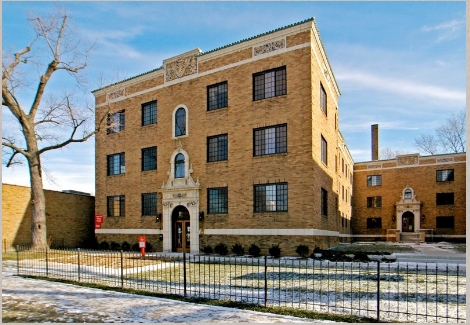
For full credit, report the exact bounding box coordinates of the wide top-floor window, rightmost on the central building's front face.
[253,67,287,100]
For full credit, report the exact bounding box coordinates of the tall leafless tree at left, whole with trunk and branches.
[2,8,106,248]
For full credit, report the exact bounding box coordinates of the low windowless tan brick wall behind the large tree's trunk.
[2,184,95,247]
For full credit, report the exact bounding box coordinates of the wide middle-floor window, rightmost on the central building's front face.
[253,124,287,156]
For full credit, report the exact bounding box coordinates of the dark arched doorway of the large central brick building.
[171,205,191,252]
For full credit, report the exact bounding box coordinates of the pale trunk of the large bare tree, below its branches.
[28,155,48,249]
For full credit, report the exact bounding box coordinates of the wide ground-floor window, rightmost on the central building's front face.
[254,183,287,212]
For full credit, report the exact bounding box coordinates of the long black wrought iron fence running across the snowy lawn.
[17,247,466,323]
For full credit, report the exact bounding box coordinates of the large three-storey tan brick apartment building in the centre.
[93,18,353,254]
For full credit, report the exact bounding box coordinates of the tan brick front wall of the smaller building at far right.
[353,153,466,241]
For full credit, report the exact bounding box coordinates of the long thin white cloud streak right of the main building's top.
[336,70,466,105]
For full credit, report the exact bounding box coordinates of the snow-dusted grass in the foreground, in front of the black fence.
[2,261,332,323]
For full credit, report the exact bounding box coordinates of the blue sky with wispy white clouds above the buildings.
[2,1,466,195]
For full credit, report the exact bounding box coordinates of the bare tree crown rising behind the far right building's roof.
[415,110,466,155]
